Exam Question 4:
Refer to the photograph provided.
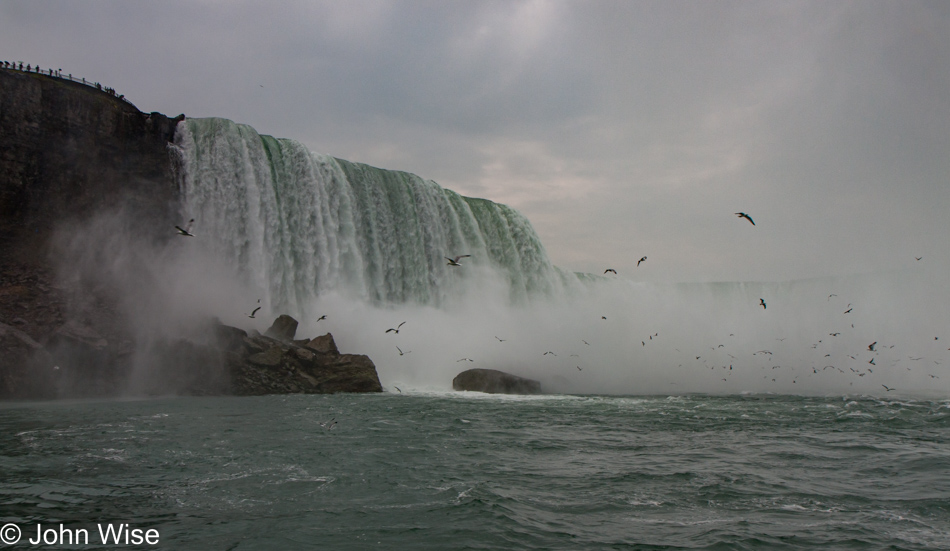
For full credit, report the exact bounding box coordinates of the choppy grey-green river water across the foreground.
[0,393,950,550]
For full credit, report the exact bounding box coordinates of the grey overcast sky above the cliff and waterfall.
[0,0,950,281]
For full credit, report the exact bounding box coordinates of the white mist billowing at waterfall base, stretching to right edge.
[278,268,950,395]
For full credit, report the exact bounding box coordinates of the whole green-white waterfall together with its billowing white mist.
[176,119,950,394]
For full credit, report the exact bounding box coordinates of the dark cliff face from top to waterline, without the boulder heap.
[0,69,183,397]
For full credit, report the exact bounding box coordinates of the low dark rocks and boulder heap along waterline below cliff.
[0,316,383,399]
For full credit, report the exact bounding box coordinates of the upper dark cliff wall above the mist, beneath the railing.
[0,69,184,244]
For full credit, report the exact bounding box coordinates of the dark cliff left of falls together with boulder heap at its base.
[0,68,381,398]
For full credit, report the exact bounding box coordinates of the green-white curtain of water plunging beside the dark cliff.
[176,118,576,311]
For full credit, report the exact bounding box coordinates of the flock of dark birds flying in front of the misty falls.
[175,212,950,396]
